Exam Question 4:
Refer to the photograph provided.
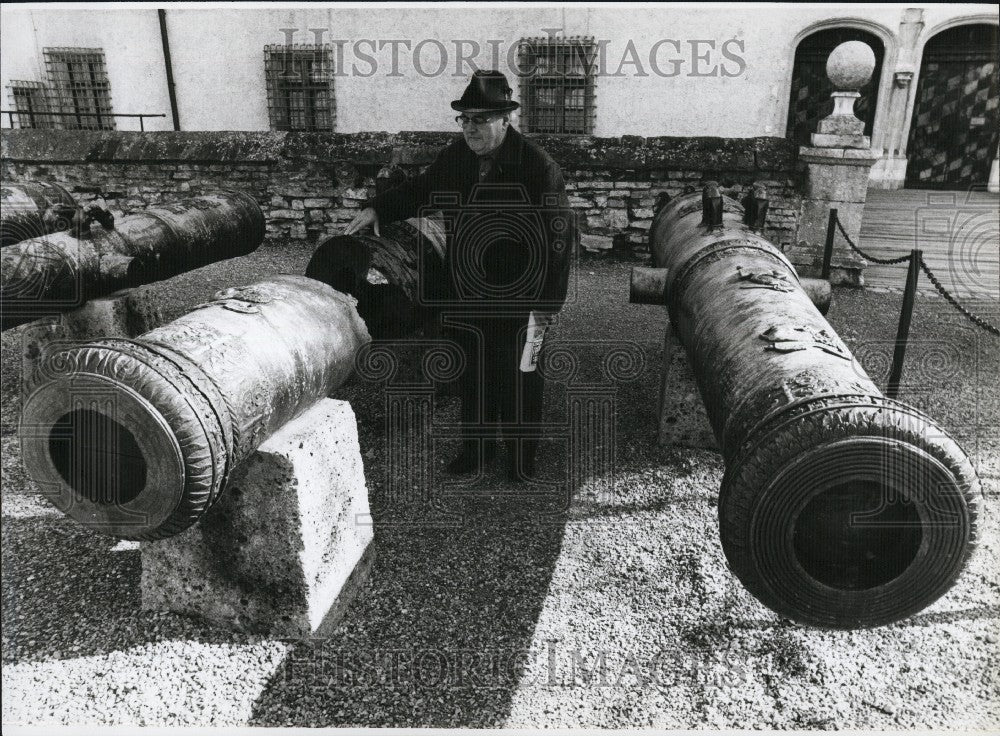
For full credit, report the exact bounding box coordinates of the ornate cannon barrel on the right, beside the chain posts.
[650,186,980,628]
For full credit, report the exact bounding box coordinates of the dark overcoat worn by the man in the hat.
[369,128,576,313]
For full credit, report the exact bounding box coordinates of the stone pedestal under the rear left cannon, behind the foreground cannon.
[21,286,163,397]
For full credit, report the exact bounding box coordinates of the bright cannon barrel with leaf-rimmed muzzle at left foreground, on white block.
[20,276,370,540]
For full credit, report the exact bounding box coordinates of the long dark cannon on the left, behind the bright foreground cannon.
[0,192,264,329]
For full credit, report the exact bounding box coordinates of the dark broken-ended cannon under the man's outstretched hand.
[306,218,446,338]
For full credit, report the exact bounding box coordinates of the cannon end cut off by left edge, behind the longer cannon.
[0,181,77,247]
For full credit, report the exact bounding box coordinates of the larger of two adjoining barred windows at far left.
[42,48,115,130]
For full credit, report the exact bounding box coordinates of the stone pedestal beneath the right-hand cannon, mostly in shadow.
[656,323,719,450]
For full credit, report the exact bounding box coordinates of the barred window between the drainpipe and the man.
[264,44,337,131]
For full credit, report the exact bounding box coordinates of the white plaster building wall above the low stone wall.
[0,3,997,137]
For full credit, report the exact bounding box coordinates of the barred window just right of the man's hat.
[518,36,595,134]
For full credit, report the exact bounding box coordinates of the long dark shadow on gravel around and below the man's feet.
[251,341,651,727]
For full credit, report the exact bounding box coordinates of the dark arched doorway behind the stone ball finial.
[785,28,885,146]
